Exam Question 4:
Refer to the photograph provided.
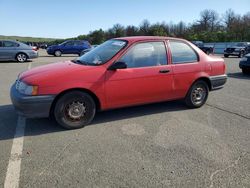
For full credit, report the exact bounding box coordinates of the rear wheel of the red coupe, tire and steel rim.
[185,80,209,108]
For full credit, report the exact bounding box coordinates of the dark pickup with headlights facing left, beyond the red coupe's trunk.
[224,42,250,58]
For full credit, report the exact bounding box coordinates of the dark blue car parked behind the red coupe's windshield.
[47,40,91,57]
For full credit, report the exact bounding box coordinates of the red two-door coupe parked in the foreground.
[11,36,227,129]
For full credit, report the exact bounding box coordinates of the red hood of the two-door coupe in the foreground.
[19,61,100,85]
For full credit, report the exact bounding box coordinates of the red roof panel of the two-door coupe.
[115,36,186,42]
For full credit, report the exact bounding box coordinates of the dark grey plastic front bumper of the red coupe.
[10,84,55,118]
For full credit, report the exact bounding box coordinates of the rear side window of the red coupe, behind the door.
[170,41,198,64]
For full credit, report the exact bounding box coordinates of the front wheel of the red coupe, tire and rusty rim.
[54,91,96,129]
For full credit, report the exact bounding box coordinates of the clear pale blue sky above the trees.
[0,0,250,38]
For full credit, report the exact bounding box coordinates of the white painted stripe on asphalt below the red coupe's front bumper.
[4,116,26,188]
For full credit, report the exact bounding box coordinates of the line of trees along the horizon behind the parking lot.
[50,9,250,44]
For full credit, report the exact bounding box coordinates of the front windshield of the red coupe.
[77,40,127,65]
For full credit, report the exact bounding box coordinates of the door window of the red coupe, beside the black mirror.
[119,42,167,68]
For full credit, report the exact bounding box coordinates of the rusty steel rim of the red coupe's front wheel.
[65,101,86,121]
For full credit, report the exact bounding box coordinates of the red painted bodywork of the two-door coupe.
[20,37,225,110]
